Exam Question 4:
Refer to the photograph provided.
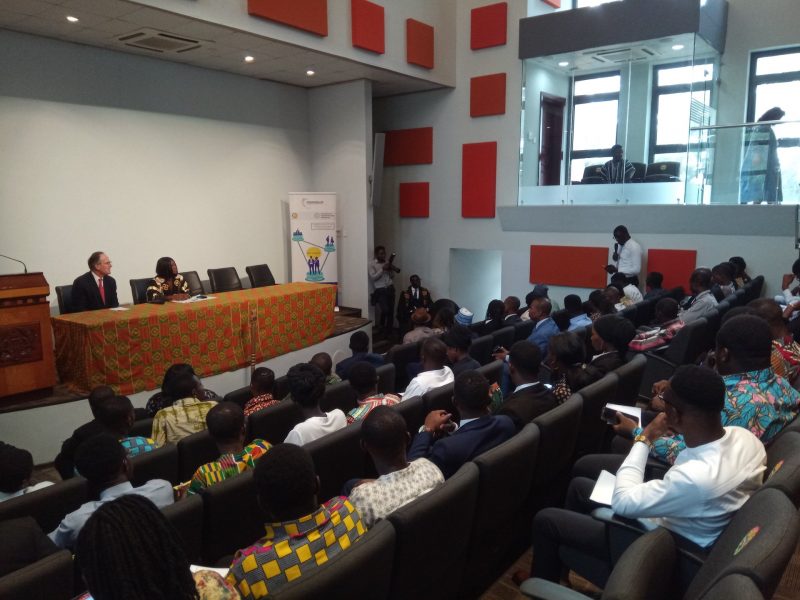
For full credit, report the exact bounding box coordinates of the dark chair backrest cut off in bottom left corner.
[0,550,74,600]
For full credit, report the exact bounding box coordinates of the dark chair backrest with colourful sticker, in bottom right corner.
[685,489,800,599]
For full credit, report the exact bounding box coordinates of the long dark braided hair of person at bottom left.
[75,494,199,600]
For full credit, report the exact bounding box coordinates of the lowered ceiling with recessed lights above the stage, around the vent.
[0,0,442,96]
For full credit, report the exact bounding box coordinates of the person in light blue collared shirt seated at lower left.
[49,433,173,548]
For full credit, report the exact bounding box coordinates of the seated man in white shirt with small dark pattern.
[349,406,444,528]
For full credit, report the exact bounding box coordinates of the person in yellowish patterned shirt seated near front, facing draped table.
[151,371,217,446]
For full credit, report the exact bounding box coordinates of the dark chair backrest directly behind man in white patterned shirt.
[387,462,478,599]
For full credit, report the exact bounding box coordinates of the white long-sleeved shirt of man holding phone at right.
[611,427,767,548]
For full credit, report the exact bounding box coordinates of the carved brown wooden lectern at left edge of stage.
[0,273,56,398]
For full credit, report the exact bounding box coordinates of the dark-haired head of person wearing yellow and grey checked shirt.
[253,442,317,519]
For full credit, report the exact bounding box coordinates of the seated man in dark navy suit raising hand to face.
[408,371,517,479]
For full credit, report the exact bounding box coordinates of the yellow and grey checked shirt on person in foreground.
[228,497,366,599]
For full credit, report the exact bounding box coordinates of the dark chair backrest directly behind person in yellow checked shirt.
[270,521,395,600]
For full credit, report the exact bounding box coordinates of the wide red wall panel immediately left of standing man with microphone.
[530,246,608,289]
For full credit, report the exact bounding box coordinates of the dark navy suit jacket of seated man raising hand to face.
[408,415,517,479]
